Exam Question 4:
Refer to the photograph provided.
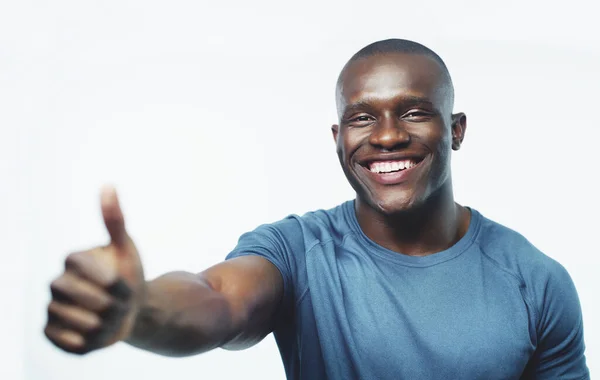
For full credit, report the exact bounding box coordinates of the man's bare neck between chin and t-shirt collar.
[356,183,471,256]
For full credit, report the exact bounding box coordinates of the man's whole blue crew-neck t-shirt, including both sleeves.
[228,201,589,380]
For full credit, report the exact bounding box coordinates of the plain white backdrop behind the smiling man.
[0,0,600,380]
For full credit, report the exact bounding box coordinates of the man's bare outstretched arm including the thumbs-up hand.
[44,189,284,356]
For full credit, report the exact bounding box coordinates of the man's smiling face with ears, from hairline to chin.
[332,53,466,215]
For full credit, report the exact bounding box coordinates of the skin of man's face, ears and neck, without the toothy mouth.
[332,53,470,256]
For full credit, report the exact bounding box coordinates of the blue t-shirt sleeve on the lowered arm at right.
[527,262,589,380]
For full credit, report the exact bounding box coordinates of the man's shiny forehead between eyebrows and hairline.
[338,53,447,105]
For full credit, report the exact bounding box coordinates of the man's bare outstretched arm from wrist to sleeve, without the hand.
[125,256,283,356]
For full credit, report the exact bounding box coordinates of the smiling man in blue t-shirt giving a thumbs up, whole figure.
[45,40,589,380]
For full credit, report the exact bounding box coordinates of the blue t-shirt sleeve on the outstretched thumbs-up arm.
[225,217,304,314]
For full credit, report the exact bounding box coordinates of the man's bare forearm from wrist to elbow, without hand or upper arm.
[126,272,236,356]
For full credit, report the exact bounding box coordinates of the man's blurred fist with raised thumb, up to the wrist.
[44,188,145,354]
